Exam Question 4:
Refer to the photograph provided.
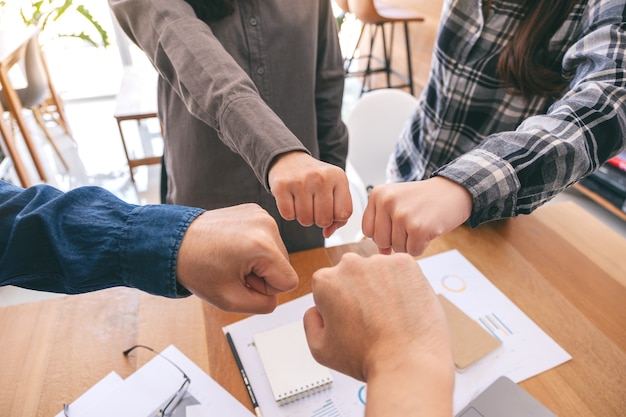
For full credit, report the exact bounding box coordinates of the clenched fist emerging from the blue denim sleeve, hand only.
[176,204,298,313]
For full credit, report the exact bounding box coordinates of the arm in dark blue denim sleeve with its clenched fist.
[0,181,298,313]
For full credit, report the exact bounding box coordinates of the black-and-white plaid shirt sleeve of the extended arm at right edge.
[435,1,626,226]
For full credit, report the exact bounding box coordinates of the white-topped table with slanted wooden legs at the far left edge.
[0,27,47,187]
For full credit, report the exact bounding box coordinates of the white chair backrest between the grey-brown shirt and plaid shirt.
[346,89,418,193]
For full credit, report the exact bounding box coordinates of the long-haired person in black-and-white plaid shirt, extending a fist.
[363,0,626,255]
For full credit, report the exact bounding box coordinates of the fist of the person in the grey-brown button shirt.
[269,152,352,238]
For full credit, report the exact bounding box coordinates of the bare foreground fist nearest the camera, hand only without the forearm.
[304,253,451,381]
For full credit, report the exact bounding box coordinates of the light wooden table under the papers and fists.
[0,203,626,417]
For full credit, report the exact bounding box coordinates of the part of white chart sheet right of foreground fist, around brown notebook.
[418,250,571,414]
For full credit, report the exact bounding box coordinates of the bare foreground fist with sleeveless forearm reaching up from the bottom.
[304,254,454,417]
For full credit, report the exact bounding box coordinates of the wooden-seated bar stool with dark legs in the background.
[342,0,424,94]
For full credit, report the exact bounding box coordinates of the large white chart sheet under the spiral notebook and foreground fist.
[224,250,571,417]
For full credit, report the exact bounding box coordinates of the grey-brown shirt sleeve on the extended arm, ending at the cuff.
[109,0,310,190]
